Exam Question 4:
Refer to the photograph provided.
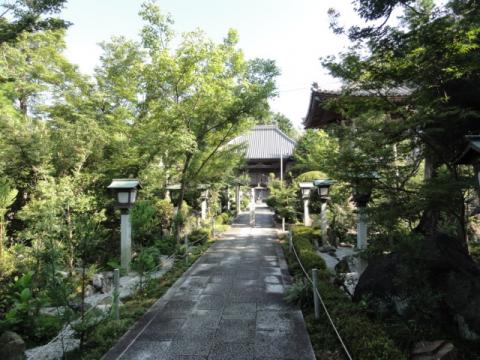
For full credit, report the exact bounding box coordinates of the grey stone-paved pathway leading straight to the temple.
[103,206,315,360]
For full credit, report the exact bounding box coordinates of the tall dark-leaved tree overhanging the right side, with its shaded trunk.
[324,0,480,241]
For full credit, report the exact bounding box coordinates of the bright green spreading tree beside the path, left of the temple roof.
[133,2,278,215]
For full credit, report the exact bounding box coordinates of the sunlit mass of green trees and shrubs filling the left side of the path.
[0,0,278,348]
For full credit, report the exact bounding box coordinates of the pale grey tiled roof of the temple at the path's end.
[230,125,297,160]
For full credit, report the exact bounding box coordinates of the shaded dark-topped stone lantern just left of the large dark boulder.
[352,173,378,250]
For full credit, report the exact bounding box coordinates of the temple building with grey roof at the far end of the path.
[230,125,296,199]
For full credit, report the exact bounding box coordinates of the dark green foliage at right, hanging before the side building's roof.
[323,0,480,242]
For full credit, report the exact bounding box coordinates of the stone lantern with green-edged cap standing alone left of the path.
[108,179,141,272]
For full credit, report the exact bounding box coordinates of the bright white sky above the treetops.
[62,0,366,128]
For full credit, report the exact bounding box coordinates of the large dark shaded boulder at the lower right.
[353,235,480,340]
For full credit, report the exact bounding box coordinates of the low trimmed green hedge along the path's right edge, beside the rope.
[284,226,407,360]
